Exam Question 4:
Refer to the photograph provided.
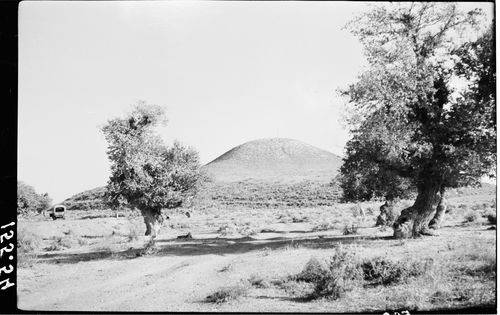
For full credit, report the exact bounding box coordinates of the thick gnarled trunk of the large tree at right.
[393,178,441,238]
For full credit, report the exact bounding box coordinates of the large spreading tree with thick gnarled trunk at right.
[342,3,496,237]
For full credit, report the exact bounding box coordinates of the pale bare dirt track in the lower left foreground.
[18,251,236,311]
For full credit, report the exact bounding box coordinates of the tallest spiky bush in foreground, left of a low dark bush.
[294,247,362,300]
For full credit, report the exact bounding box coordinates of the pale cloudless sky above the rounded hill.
[18,1,492,202]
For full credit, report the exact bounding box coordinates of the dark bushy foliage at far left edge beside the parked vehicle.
[17,181,52,214]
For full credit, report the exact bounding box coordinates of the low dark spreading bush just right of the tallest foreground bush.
[361,257,433,285]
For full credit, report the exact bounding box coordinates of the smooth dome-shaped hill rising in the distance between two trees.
[203,138,342,182]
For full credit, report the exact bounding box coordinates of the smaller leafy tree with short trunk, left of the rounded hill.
[102,102,201,238]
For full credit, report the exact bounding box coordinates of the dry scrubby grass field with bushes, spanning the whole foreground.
[17,189,496,312]
